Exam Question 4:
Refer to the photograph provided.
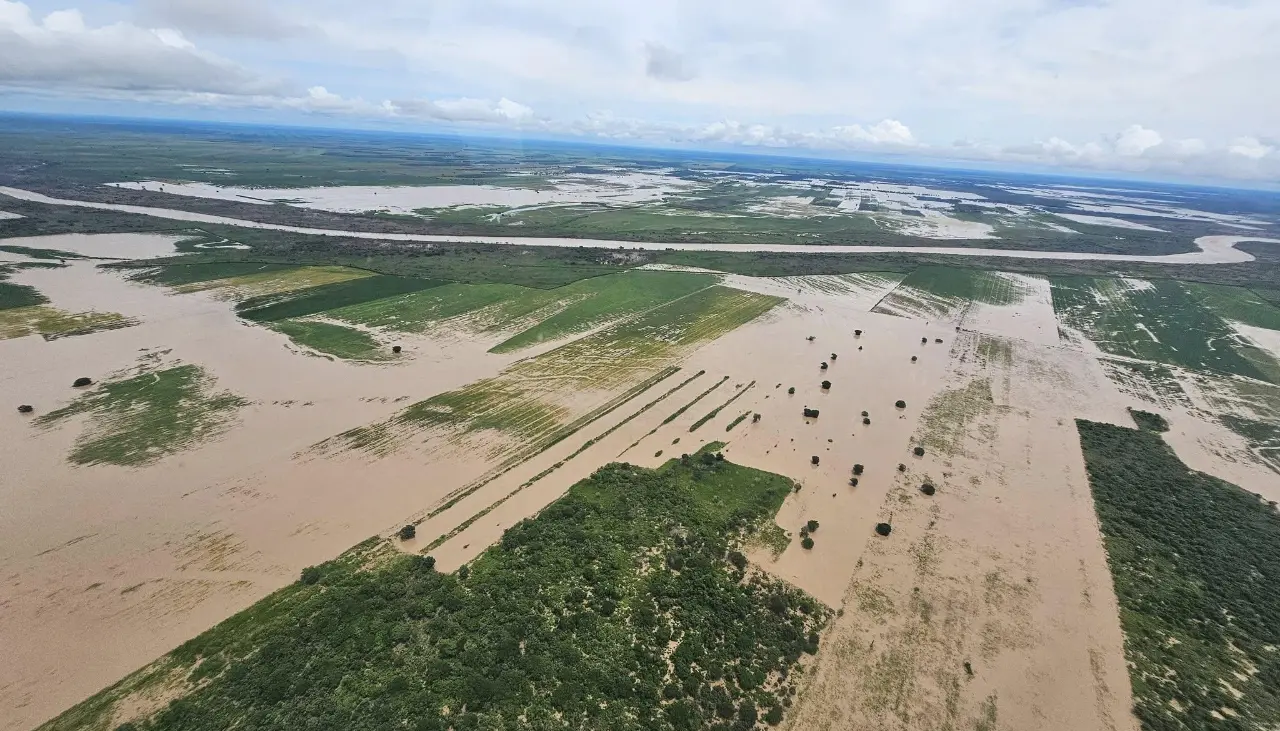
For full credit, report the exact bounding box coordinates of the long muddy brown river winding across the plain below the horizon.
[0,187,1280,264]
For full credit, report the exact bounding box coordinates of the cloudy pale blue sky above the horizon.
[0,0,1280,184]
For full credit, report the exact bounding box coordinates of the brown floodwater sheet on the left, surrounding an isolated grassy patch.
[0,262,517,730]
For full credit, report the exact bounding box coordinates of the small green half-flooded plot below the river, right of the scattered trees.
[872,266,1025,320]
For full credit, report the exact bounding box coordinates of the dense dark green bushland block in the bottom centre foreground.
[42,454,831,731]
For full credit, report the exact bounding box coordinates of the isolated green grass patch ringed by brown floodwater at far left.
[36,365,247,467]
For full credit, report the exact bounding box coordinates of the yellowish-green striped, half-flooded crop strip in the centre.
[319,287,781,453]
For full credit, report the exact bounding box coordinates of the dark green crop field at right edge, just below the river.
[1051,277,1280,383]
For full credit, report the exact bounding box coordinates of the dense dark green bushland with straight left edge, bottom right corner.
[1076,420,1280,731]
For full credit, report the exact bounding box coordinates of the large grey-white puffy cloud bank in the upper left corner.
[0,0,283,95]
